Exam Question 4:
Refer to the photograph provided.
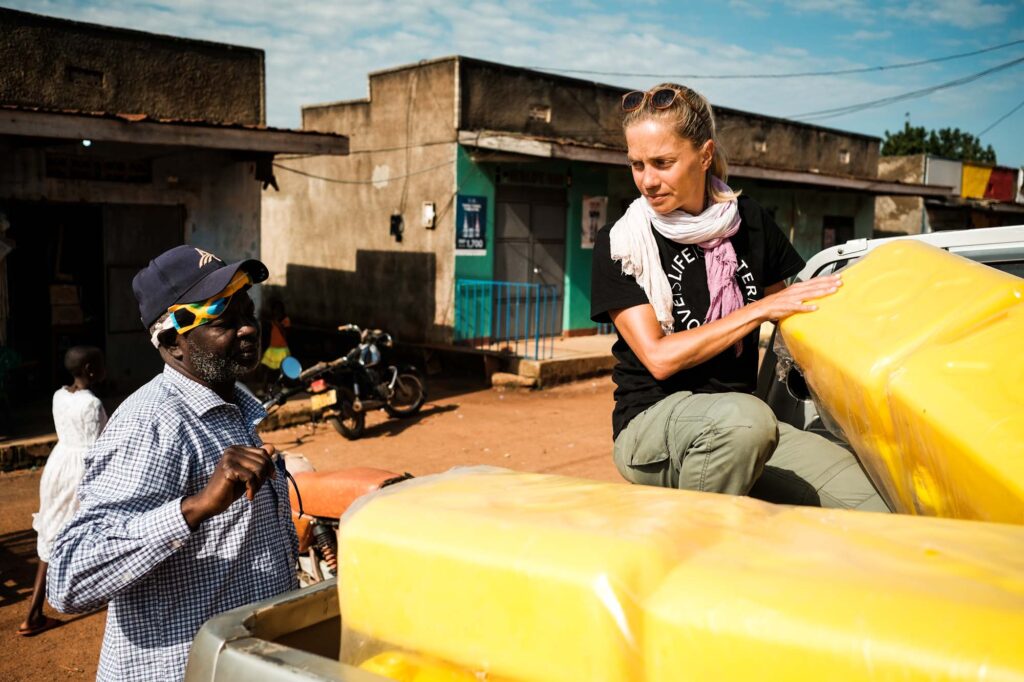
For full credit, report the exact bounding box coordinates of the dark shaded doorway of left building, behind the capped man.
[0,202,184,438]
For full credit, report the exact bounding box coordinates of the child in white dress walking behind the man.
[17,346,106,637]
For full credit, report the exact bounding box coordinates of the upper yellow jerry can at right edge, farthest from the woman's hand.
[889,305,1024,520]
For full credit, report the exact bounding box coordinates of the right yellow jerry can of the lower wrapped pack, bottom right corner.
[644,508,1024,682]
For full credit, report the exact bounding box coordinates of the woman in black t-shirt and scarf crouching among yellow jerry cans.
[591,83,888,511]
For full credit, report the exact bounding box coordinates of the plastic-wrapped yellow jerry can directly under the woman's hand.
[779,240,1024,513]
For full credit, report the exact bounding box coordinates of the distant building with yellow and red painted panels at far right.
[874,154,1024,236]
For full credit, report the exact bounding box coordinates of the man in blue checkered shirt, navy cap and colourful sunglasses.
[47,246,298,682]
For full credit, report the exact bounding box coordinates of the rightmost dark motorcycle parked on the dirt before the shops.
[323,325,427,440]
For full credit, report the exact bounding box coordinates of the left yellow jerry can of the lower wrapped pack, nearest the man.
[338,469,745,682]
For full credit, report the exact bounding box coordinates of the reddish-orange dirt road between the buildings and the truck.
[0,378,621,682]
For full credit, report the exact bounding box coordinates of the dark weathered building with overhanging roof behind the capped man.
[0,9,348,436]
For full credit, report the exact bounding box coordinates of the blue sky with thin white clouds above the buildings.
[8,0,1024,166]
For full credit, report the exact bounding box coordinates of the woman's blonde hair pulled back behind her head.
[623,83,739,206]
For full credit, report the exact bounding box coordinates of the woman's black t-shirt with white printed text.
[591,196,804,437]
